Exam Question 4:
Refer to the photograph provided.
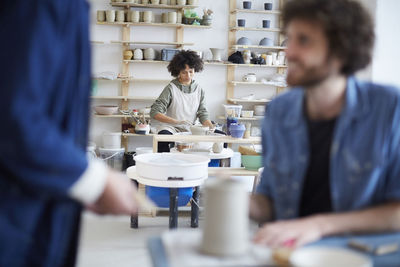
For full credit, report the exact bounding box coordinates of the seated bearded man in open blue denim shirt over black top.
[250,0,400,247]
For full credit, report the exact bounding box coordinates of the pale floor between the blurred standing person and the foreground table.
[77,212,195,267]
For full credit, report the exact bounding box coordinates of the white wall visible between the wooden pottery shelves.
[89,0,278,150]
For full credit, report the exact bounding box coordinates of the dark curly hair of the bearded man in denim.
[282,0,375,76]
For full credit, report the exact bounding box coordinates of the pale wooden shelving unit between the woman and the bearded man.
[225,0,287,124]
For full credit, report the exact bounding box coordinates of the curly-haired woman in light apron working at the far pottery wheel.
[150,50,213,152]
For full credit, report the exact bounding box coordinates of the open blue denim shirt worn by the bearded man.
[257,77,400,220]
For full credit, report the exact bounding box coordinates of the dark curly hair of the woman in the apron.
[168,50,203,77]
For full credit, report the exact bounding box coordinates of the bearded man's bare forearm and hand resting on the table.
[254,202,400,247]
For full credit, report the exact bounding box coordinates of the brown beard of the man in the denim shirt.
[287,57,333,88]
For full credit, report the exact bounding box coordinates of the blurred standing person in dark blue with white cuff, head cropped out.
[0,0,137,267]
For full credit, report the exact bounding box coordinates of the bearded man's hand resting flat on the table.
[254,216,323,248]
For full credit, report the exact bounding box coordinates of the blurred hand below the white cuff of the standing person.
[87,170,138,215]
